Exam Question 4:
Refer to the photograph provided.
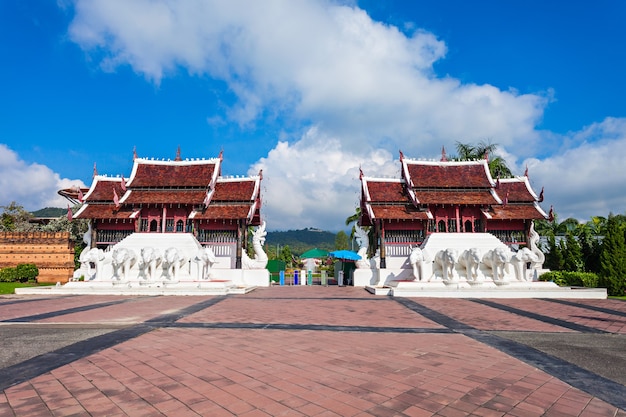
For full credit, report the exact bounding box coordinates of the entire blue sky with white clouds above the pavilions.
[0,0,626,230]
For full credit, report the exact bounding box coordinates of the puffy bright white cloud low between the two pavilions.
[250,128,400,231]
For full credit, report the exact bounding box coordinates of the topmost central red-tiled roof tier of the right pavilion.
[403,160,492,188]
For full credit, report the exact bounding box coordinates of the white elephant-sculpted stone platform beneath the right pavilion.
[353,233,607,299]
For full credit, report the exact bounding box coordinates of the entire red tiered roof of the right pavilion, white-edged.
[361,155,547,223]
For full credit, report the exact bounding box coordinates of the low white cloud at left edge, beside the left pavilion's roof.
[0,143,85,211]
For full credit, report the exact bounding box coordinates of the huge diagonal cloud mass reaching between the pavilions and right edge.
[63,0,626,229]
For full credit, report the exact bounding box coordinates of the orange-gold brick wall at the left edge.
[0,232,74,284]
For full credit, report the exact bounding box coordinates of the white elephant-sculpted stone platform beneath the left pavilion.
[16,233,270,295]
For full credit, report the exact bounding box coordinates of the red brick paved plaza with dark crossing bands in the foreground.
[0,286,626,416]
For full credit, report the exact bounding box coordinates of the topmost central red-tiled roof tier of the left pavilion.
[128,159,217,187]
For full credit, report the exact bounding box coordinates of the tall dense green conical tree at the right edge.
[600,215,626,295]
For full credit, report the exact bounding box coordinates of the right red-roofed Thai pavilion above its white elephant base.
[360,153,549,267]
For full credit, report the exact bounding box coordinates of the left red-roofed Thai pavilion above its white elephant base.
[59,150,262,265]
